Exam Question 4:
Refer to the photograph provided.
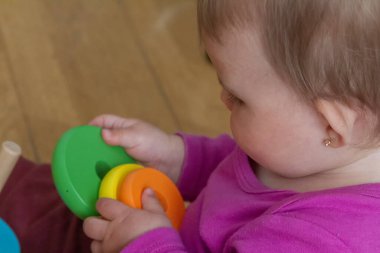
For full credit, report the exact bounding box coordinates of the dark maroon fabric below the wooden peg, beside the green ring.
[0,158,90,253]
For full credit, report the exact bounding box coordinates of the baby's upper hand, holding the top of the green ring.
[90,115,185,182]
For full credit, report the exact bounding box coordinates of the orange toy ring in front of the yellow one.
[119,168,185,229]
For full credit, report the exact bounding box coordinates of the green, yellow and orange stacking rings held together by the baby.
[52,126,185,228]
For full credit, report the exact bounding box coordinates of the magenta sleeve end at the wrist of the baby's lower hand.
[121,228,188,253]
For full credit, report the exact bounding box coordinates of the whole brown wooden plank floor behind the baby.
[0,0,228,162]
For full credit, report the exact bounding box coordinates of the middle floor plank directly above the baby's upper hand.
[42,0,177,130]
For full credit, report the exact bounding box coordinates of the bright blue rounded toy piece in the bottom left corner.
[0,219,21,253]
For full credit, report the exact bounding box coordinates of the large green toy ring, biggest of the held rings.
[52,126,136,219]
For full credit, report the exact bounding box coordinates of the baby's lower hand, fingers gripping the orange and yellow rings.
[83,189,172,253]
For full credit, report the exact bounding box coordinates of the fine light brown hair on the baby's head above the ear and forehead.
[198,0,380,139]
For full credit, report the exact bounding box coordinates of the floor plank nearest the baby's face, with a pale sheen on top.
[121,0,228,135]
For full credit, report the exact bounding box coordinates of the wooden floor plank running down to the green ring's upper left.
[0,1,80,162]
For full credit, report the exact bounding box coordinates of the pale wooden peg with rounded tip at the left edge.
[0,141,21,192]
